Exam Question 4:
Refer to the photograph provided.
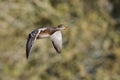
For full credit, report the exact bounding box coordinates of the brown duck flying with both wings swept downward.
[26,24,69,59]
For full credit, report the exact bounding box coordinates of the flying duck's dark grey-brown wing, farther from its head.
[26,30,39,58]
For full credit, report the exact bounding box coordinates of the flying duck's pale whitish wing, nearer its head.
[50,31,62,53]
